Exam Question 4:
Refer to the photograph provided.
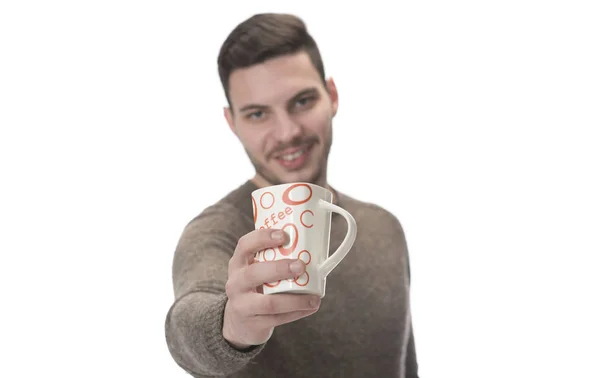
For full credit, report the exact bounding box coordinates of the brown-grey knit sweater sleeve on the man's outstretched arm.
[165,205,264,378]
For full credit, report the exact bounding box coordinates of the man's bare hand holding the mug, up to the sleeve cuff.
[223,229,321,349]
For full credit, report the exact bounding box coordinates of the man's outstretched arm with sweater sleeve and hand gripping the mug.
[165,205,320,378]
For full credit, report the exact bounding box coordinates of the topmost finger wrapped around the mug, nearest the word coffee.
[229,229,288,270]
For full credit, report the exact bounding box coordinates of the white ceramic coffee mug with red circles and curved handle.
[252,182,357,298]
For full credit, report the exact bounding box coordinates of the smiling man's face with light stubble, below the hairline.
[225,52,338,186]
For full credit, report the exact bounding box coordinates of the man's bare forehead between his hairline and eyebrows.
[229,52,323,108]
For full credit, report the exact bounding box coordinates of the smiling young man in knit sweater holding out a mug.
[165,14,418,378]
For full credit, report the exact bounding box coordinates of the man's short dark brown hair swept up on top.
[217,13,325,106]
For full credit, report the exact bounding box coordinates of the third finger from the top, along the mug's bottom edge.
[247,294,321,315]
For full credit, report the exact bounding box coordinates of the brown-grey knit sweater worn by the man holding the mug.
[165,181,418,378]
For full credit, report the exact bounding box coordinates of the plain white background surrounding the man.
[0,0,600,378]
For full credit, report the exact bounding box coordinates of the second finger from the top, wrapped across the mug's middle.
[233,259,306,291]
